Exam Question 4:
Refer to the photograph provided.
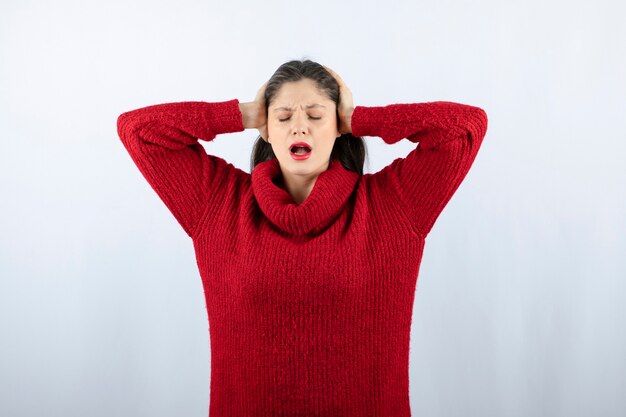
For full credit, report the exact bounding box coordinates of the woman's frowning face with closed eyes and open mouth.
[267,79,341,180]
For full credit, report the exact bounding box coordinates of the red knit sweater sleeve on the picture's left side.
[117,99,244,237]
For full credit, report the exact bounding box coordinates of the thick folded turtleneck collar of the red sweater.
[252,158,360,235]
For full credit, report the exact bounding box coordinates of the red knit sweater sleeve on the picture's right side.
[351,101,487,237]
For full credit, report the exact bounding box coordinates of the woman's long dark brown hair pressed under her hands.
[250,59,367,175]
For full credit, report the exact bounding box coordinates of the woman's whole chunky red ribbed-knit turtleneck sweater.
[117,99,487,417]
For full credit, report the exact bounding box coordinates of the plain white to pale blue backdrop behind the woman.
[0,0,626,417]
